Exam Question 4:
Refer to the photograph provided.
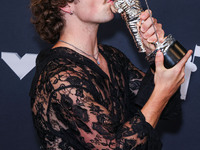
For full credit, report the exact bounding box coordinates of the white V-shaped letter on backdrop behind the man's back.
[1,52,37,80]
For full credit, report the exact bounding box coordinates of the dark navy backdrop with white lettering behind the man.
[0,0,200,150]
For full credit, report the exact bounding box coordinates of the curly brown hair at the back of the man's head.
[30,0,74,44]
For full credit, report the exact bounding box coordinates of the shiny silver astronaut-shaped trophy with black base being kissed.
[114,0,187,69]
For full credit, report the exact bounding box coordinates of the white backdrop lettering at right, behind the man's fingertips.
[181,45,200,100]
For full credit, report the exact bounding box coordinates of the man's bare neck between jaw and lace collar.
[55,18,99,55]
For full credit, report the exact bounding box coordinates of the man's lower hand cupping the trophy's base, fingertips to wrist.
[154,50,192,97]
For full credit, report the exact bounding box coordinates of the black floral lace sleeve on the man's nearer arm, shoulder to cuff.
[32,59,159,150]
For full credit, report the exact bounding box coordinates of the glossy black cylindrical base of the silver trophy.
[150,41,187,71]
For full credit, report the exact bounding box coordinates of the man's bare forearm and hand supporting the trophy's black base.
[141,50,192,128]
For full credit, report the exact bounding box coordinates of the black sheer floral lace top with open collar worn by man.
[30,45,179,150]
